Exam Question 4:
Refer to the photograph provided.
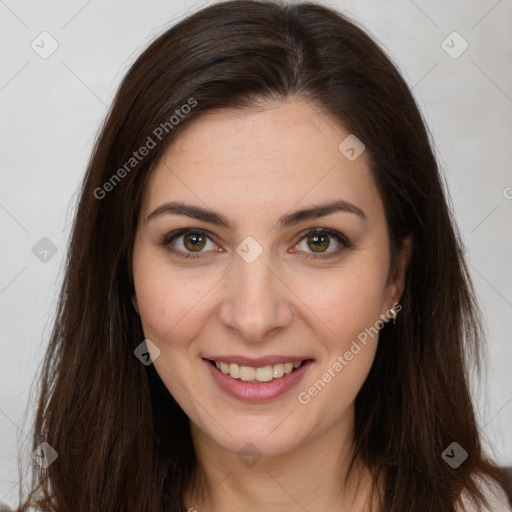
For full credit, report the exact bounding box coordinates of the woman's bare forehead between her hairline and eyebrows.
[143,100,380,222]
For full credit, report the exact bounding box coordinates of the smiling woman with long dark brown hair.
[14,0,507,512]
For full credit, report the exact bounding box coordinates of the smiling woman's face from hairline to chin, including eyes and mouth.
[133,100,405,455]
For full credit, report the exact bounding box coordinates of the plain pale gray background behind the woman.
[0,0,512,504]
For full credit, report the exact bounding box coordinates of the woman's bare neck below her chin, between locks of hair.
[184,408,376,512]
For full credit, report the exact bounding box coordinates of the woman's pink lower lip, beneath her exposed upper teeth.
[204,359,313,402]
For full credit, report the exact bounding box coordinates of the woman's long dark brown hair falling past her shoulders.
[15,0,504,512]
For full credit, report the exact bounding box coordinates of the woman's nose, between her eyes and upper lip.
[219,251,295,343]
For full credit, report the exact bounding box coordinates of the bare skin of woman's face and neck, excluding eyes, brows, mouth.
[133,99,410,512]
